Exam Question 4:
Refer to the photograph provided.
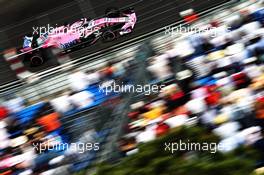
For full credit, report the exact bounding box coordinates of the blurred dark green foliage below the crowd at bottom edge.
[97,127,257,175]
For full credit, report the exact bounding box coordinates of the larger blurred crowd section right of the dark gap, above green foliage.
[119,1,264,170]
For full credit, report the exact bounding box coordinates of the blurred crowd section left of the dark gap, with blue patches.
[0,57,136,174]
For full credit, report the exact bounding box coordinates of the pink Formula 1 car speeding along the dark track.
[20,8,137,66]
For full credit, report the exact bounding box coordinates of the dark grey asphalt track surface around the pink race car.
[0,0,227,84]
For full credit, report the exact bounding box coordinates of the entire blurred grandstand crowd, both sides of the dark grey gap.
[0,0,264,175]
